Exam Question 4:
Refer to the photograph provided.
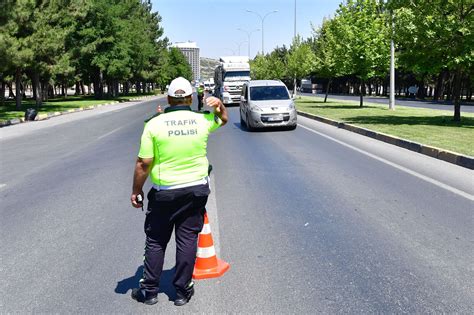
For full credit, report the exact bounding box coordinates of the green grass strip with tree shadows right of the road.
[296,96,474,156]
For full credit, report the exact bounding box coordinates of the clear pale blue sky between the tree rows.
[152,0,341,59]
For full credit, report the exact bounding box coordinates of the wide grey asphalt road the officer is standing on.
[0,99,474,314]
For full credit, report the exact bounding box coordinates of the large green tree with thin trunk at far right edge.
[390,0,474,121]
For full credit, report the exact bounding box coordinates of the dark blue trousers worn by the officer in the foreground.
[140,185,210,294]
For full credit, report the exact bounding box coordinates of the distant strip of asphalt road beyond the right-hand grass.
[301,93,474,113]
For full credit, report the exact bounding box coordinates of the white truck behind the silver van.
[214,56,250,105]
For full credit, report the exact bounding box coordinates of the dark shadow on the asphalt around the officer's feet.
[115,266,176,301]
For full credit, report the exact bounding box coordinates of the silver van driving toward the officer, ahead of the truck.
[240,80,297,130]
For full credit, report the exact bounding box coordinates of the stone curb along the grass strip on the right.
[297,111,474,170]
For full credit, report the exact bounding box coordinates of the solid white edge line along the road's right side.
[298,124,474,200]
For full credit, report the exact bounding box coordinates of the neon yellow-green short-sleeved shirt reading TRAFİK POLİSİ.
[138,106,222,186]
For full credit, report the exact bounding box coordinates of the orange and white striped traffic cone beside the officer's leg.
[193,213,230,279]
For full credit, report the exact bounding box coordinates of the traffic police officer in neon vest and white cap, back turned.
[131,77,228,306]
